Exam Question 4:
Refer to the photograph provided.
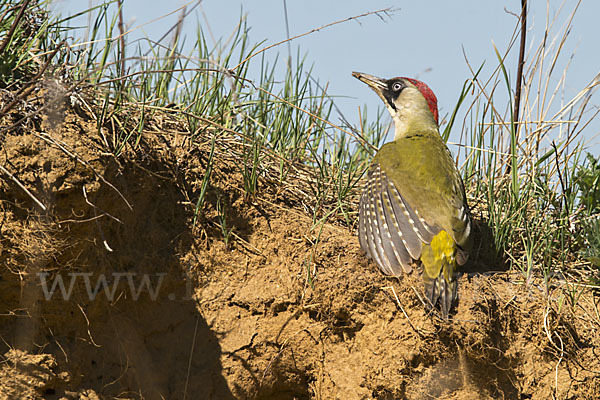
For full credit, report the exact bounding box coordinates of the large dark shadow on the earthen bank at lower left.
[0,151,233,399]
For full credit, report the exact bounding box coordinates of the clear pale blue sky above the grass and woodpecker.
[52,0,600,150]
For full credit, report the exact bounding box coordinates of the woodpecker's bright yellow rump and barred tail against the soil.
[421,231,458,318]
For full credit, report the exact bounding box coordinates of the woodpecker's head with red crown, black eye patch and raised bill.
[352,72,438,138]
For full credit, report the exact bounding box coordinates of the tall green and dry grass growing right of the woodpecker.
[453,1,598,290]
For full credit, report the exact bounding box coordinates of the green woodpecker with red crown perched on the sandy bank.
[352,72,471,318]
